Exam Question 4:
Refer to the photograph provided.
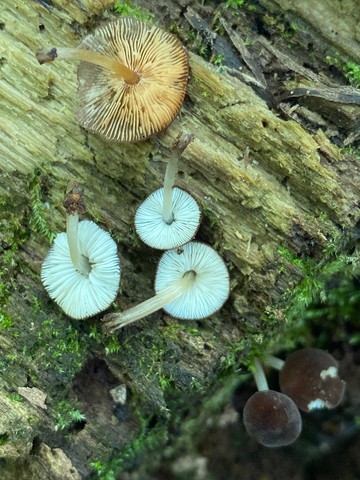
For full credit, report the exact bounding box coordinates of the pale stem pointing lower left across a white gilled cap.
[102,270,196,332]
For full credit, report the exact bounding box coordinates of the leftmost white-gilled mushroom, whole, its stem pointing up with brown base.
[41,182,120,319]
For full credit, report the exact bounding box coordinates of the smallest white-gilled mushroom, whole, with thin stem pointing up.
[135,134,201,250]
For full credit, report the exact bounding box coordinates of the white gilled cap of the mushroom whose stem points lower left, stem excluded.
[155,242,230,320]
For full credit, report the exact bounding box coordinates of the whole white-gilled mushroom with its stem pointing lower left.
[103,242,230,332]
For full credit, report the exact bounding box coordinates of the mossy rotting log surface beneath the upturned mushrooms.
[0,0,360,479]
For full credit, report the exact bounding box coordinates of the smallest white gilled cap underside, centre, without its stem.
[135,187,201,250]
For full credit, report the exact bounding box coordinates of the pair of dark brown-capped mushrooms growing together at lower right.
[243,348,345,447]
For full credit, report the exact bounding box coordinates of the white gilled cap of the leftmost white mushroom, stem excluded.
[41,220,120,319]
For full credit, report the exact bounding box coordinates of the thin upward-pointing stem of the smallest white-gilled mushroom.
[162,134,194,225]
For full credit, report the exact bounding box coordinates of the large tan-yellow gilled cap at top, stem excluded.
[78,17,189,142]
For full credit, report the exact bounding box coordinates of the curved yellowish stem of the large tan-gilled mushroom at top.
[37,47,140,85]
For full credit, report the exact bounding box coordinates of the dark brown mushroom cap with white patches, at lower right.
[279,348,345,412]
